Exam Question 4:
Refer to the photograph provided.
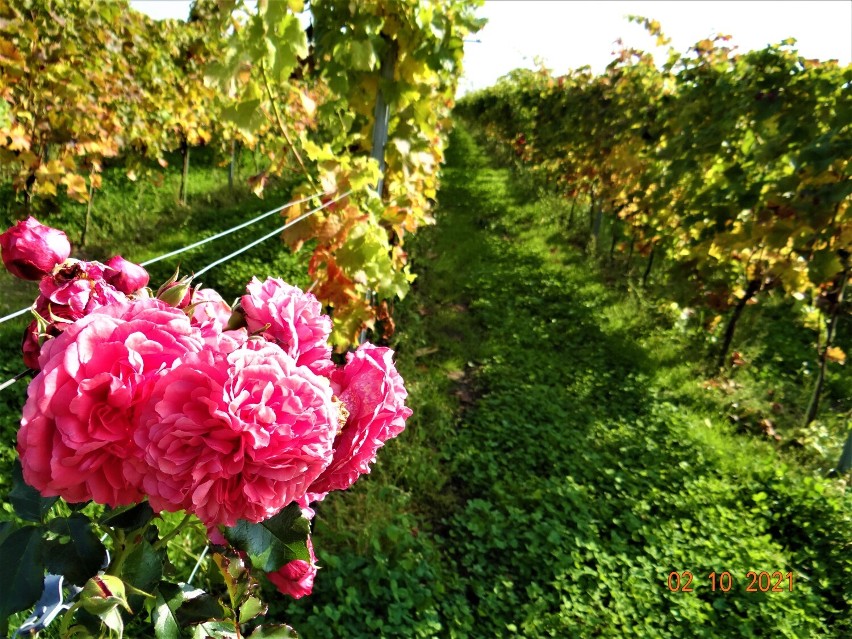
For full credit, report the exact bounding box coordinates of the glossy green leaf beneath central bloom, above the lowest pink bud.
[224,503,311,572]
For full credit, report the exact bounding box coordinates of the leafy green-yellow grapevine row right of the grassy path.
[458,18,852,428]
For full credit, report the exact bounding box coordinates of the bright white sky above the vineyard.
[131,0,852,93]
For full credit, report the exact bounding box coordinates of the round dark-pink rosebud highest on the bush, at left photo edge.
[0,216,71,280]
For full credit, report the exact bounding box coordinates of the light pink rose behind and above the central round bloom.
[240,277,334,375]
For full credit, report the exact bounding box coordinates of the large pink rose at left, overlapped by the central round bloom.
[18,299,202,506]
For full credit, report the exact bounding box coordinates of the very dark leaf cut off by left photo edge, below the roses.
[0,526,44,627]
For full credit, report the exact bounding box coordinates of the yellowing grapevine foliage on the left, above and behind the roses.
[0,0,481,348]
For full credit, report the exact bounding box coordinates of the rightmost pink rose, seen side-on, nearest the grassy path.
[309,344,411,497]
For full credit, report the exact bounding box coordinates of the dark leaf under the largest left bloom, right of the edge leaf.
[44,513,106,586]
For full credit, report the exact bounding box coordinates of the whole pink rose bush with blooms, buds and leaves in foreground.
[0,220,411,637]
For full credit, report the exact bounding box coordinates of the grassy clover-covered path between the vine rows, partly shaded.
[276,124,852,638]
